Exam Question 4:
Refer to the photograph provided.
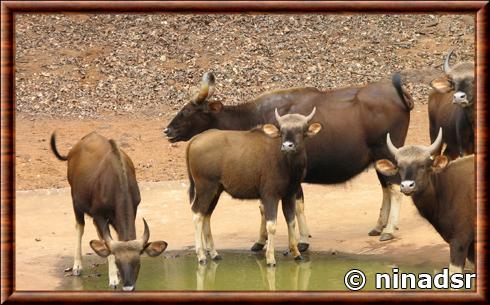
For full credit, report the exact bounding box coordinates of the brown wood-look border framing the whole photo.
[1,1,489,304]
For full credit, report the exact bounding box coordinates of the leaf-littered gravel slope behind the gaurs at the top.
[15,14,475,118]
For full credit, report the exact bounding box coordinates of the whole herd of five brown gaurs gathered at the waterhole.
[51,51,476,291]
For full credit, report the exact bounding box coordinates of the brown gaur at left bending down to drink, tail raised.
[51,132,167,291]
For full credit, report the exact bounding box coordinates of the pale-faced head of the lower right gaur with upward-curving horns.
[376,128,449,196]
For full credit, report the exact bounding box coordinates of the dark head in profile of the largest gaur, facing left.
[167,72,223,142]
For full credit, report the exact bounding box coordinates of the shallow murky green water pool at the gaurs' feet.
[59,251,474,291]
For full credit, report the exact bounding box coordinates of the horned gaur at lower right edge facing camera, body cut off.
[376,128,476,274]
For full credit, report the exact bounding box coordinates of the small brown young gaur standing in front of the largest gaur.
[186,108,322,266]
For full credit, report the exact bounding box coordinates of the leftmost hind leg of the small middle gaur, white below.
[191,181,219,264]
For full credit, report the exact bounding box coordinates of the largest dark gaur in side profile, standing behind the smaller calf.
[164,73,413,246]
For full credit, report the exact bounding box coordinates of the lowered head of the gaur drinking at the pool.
[90,219,167,291]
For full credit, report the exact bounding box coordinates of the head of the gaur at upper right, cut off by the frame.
[431,50,475,107]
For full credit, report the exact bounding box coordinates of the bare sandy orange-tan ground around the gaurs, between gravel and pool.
[15,105,449,290]
